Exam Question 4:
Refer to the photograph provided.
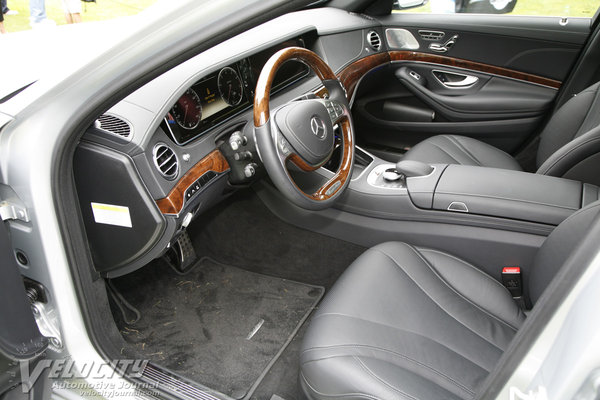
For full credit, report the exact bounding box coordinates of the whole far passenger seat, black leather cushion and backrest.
[403,82,600,185]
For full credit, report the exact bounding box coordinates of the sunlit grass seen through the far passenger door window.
[396,0,600,18]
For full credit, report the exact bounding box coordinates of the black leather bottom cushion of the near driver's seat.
[300,242,525,399]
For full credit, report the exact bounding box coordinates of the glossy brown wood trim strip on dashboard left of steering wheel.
[156,149,229,214]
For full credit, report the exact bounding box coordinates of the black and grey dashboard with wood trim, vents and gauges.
[73,8,385,278]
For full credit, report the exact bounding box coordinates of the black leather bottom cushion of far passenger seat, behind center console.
[402,135,522,171]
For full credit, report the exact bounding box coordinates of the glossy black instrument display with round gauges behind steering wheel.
[164,37,310,144]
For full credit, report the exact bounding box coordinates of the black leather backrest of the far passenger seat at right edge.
[537,82,600,184]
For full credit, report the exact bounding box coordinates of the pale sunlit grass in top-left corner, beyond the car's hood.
[4,0,156,32]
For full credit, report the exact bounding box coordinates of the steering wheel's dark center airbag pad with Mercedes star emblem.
[275,99,334,166]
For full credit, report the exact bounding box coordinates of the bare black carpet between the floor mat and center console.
[188,190,366,289]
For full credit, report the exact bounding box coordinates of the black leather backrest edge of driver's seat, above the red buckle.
[528,201,600,304]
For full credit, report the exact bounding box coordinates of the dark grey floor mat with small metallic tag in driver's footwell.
[112,258,324,398]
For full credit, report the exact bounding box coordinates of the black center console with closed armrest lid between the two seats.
[339,151,599,226]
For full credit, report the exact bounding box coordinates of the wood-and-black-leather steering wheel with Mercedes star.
[254,47,354,210]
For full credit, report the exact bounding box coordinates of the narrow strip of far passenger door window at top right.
[394,0,600,18]
